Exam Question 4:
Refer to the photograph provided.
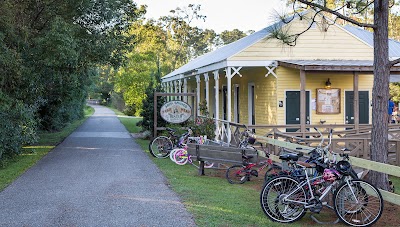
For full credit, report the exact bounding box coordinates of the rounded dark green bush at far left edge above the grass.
[0,92,37,158]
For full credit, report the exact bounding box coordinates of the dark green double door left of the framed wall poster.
[286,91,310,132]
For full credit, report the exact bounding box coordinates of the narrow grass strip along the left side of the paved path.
[0,107,94,191]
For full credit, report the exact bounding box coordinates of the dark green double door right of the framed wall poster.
[345,91,369,124]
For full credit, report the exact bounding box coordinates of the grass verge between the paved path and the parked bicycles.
[119,113,309,227]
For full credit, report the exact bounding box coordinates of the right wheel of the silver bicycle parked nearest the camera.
[333,179,383,226]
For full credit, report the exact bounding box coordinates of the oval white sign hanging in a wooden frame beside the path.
[160,100,192,123]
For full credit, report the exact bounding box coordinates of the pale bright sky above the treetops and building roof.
[134,0,284,33]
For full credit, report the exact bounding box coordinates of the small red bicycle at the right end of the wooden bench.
[225,129,282,184]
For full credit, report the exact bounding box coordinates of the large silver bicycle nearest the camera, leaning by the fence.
[260,147,383,226]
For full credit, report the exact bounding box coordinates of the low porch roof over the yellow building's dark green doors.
[278,60,400,74]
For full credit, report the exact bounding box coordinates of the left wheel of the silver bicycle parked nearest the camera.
[260,176,306,223]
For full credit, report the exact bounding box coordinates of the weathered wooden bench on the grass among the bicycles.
[187,143,259,175]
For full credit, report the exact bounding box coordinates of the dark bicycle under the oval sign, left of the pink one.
[149,128,193,158]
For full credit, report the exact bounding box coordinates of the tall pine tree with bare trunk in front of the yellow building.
[275,0,400,190]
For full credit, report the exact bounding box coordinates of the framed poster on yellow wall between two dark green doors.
[317,88,340,114]
